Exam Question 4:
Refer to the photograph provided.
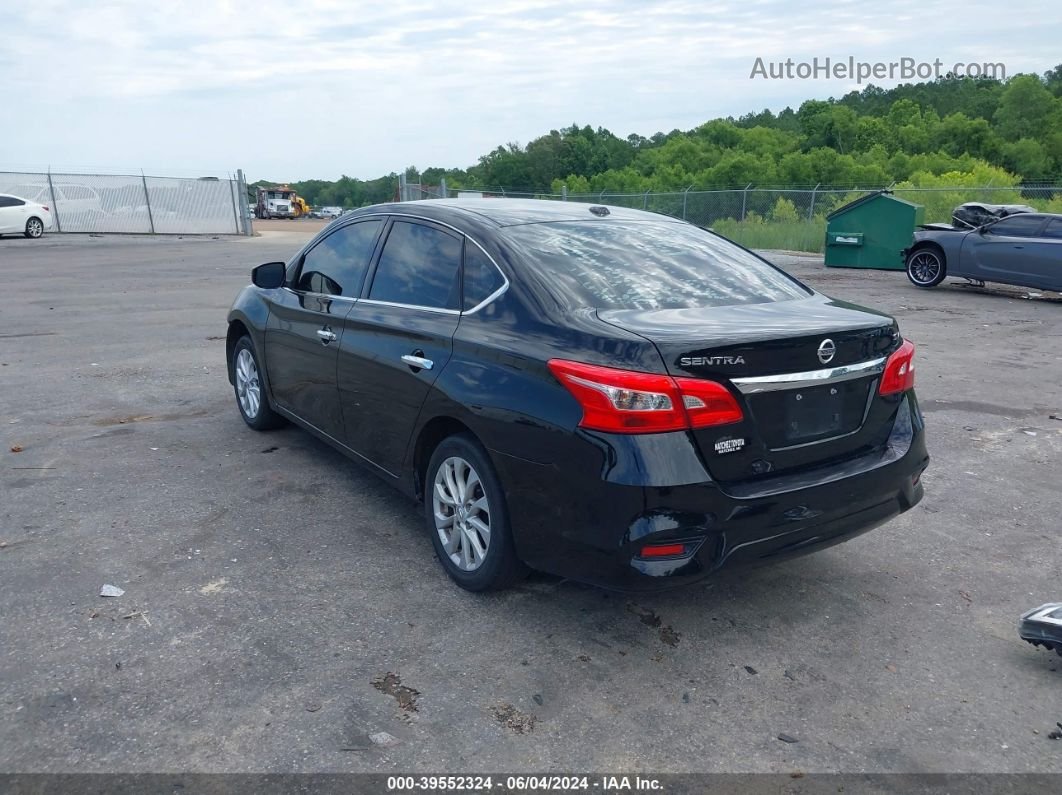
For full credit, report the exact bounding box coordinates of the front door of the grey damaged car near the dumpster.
[962,212,1046,284]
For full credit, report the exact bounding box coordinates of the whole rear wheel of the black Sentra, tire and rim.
[424,433,527,591]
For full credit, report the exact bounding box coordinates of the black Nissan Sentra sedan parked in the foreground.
[226,198,929,590]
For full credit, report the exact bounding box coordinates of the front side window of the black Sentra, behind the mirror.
[294,219,383,298]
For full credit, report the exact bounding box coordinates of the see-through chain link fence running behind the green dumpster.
[400,182,1062,253]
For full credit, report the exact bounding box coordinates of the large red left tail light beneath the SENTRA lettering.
[548,359,743,433]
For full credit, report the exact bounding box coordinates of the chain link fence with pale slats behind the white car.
[0,172,251,235]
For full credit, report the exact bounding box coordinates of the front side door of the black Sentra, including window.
[266,219,383,439]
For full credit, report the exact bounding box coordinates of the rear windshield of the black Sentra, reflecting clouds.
[504,221,810,309]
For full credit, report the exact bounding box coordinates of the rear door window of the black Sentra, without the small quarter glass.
[369,221,461,310]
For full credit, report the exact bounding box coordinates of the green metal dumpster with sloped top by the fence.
[825,190,925,271]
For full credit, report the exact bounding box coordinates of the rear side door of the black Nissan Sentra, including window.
[339,218,463,474]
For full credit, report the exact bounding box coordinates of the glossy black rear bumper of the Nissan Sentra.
[496,390,929,590]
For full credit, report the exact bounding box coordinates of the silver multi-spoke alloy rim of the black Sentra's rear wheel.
[431,455,491,571]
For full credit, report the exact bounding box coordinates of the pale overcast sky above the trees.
[0,0,1062,180]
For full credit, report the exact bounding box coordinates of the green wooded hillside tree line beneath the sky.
[256,65,1062,207]
